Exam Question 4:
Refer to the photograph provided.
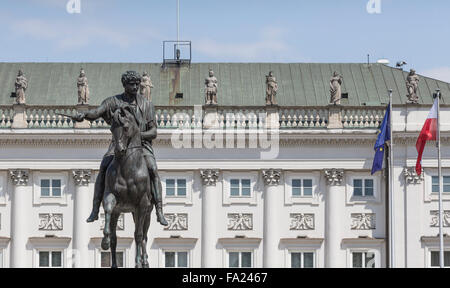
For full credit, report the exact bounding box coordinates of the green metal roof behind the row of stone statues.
[0,63,450,106]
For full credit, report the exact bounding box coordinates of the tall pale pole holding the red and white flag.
[434,89,444,268]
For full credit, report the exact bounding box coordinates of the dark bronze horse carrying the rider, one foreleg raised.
[101,106,153,268]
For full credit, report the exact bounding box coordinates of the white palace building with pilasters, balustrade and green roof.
[0,63,450,267]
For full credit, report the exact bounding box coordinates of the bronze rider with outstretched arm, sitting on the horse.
[74,71,168,226]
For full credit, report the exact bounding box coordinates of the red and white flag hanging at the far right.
[416,97,439,175]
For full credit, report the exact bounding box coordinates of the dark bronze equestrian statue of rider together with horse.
[73,71,168,267]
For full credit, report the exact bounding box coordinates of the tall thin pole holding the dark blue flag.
[388,89,395,268]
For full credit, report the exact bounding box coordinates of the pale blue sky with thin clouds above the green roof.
[0,0,450,82]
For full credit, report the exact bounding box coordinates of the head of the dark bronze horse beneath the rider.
[111,106,140,156]
